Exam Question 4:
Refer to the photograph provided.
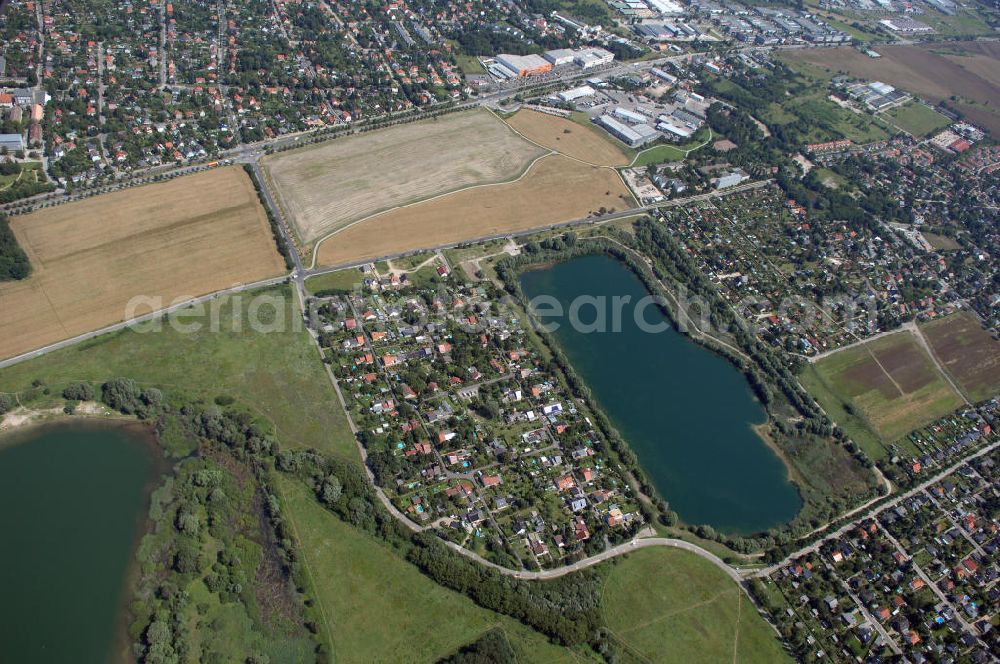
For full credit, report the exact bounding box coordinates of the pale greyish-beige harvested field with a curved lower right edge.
[262,110,545,244]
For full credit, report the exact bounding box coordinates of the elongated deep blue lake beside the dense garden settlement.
[520,255,802,534]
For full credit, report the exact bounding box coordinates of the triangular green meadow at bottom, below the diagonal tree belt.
[280,478,575,663]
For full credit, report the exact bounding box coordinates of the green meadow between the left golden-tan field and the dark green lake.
[0,287,359,461]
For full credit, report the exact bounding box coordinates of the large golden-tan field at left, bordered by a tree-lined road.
[0,166,285,358]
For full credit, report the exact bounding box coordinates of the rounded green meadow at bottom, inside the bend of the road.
[603,548,791,664]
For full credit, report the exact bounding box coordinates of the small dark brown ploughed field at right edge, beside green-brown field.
[920,311,1000,401]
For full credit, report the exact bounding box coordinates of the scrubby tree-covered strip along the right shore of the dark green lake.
[68,378,327,664]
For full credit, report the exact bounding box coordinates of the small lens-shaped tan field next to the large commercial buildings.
[507,109,631,166]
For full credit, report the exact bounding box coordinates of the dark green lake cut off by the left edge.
[0,421,159,664]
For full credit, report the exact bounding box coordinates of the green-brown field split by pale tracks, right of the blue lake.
[807,331,962,445]
